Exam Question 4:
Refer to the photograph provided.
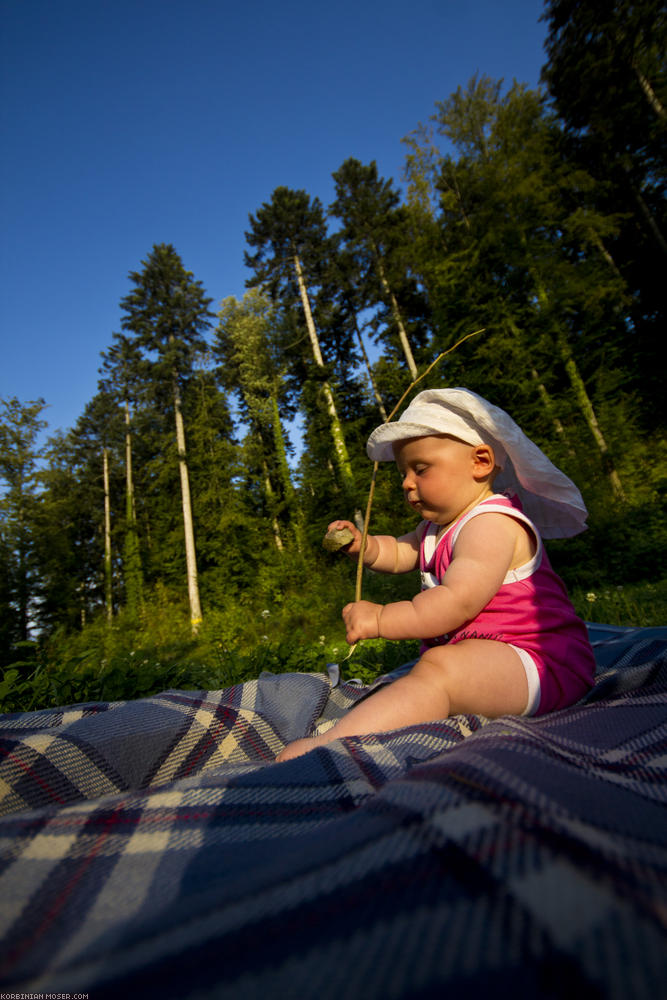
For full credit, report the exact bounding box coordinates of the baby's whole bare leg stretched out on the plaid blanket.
[277,639,528,760]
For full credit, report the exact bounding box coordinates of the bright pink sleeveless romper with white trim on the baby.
[418,494,595,715]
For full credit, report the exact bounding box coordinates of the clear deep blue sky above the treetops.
[0,0,546,446]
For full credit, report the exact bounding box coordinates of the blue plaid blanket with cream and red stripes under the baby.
[0,627,667,1000]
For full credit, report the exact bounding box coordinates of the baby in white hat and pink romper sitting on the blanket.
[278,389,595,760]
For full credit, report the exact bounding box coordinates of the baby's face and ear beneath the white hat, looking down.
[394,434,480,525]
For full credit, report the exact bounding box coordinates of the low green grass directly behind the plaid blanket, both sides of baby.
[0,580,667,712]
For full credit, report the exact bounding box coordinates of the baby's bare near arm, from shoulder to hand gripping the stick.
[343,513,522,643]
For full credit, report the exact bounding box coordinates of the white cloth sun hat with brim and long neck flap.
[366,389,588,538]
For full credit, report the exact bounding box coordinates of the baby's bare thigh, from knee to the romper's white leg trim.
[413,639,528,718]
